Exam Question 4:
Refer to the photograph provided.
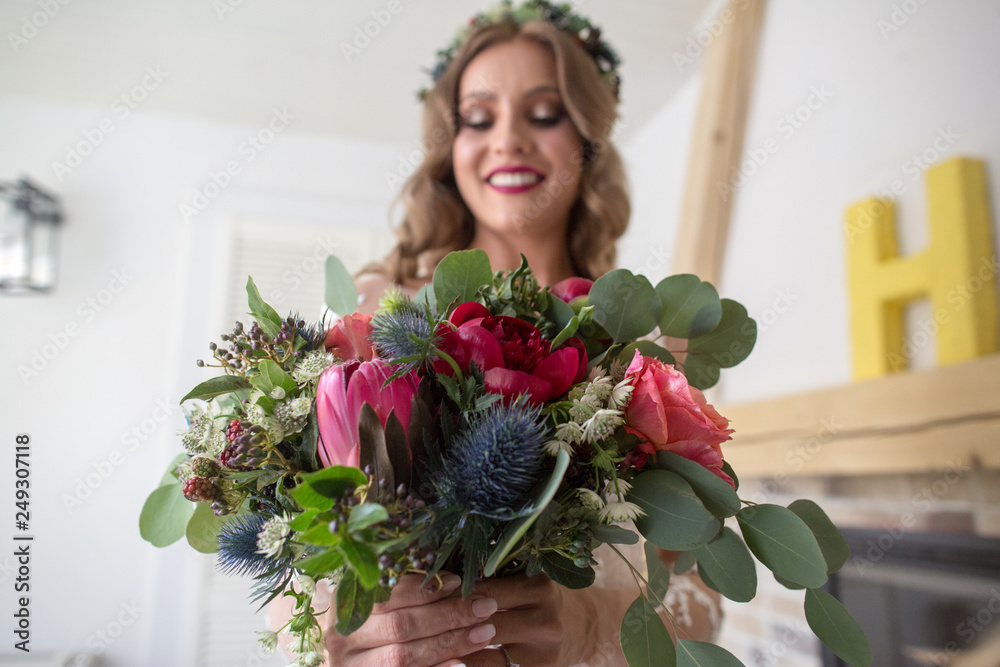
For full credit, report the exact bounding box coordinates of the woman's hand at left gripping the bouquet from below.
[324,574,504,667]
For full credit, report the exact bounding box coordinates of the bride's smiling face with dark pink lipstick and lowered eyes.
[452,39,583,243]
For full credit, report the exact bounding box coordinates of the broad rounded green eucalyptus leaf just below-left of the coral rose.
[626,470,722,551]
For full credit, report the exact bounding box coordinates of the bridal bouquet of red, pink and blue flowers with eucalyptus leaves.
[140,250,871,667]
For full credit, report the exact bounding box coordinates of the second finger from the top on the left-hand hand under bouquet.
[355,596,497,649]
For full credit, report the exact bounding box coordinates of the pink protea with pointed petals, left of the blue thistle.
[316,359,418,468]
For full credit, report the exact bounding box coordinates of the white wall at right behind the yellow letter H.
[621,0,1000,403]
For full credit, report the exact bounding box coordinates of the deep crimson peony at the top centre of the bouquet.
[434,303,587,403]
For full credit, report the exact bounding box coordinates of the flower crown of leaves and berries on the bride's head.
[417,0,621,100]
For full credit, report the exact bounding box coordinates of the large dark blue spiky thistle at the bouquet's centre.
[437,397,546,517]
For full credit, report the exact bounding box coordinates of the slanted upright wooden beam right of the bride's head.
[673,0,764,285]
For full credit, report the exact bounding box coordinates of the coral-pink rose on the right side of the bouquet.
[625,350,735,488]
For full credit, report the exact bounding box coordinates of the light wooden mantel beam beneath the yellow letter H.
[720,355,1000,477]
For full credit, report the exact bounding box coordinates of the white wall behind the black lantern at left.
[0,97,413,667]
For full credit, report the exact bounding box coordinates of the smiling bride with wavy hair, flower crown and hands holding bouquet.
[270,0,719,667]
